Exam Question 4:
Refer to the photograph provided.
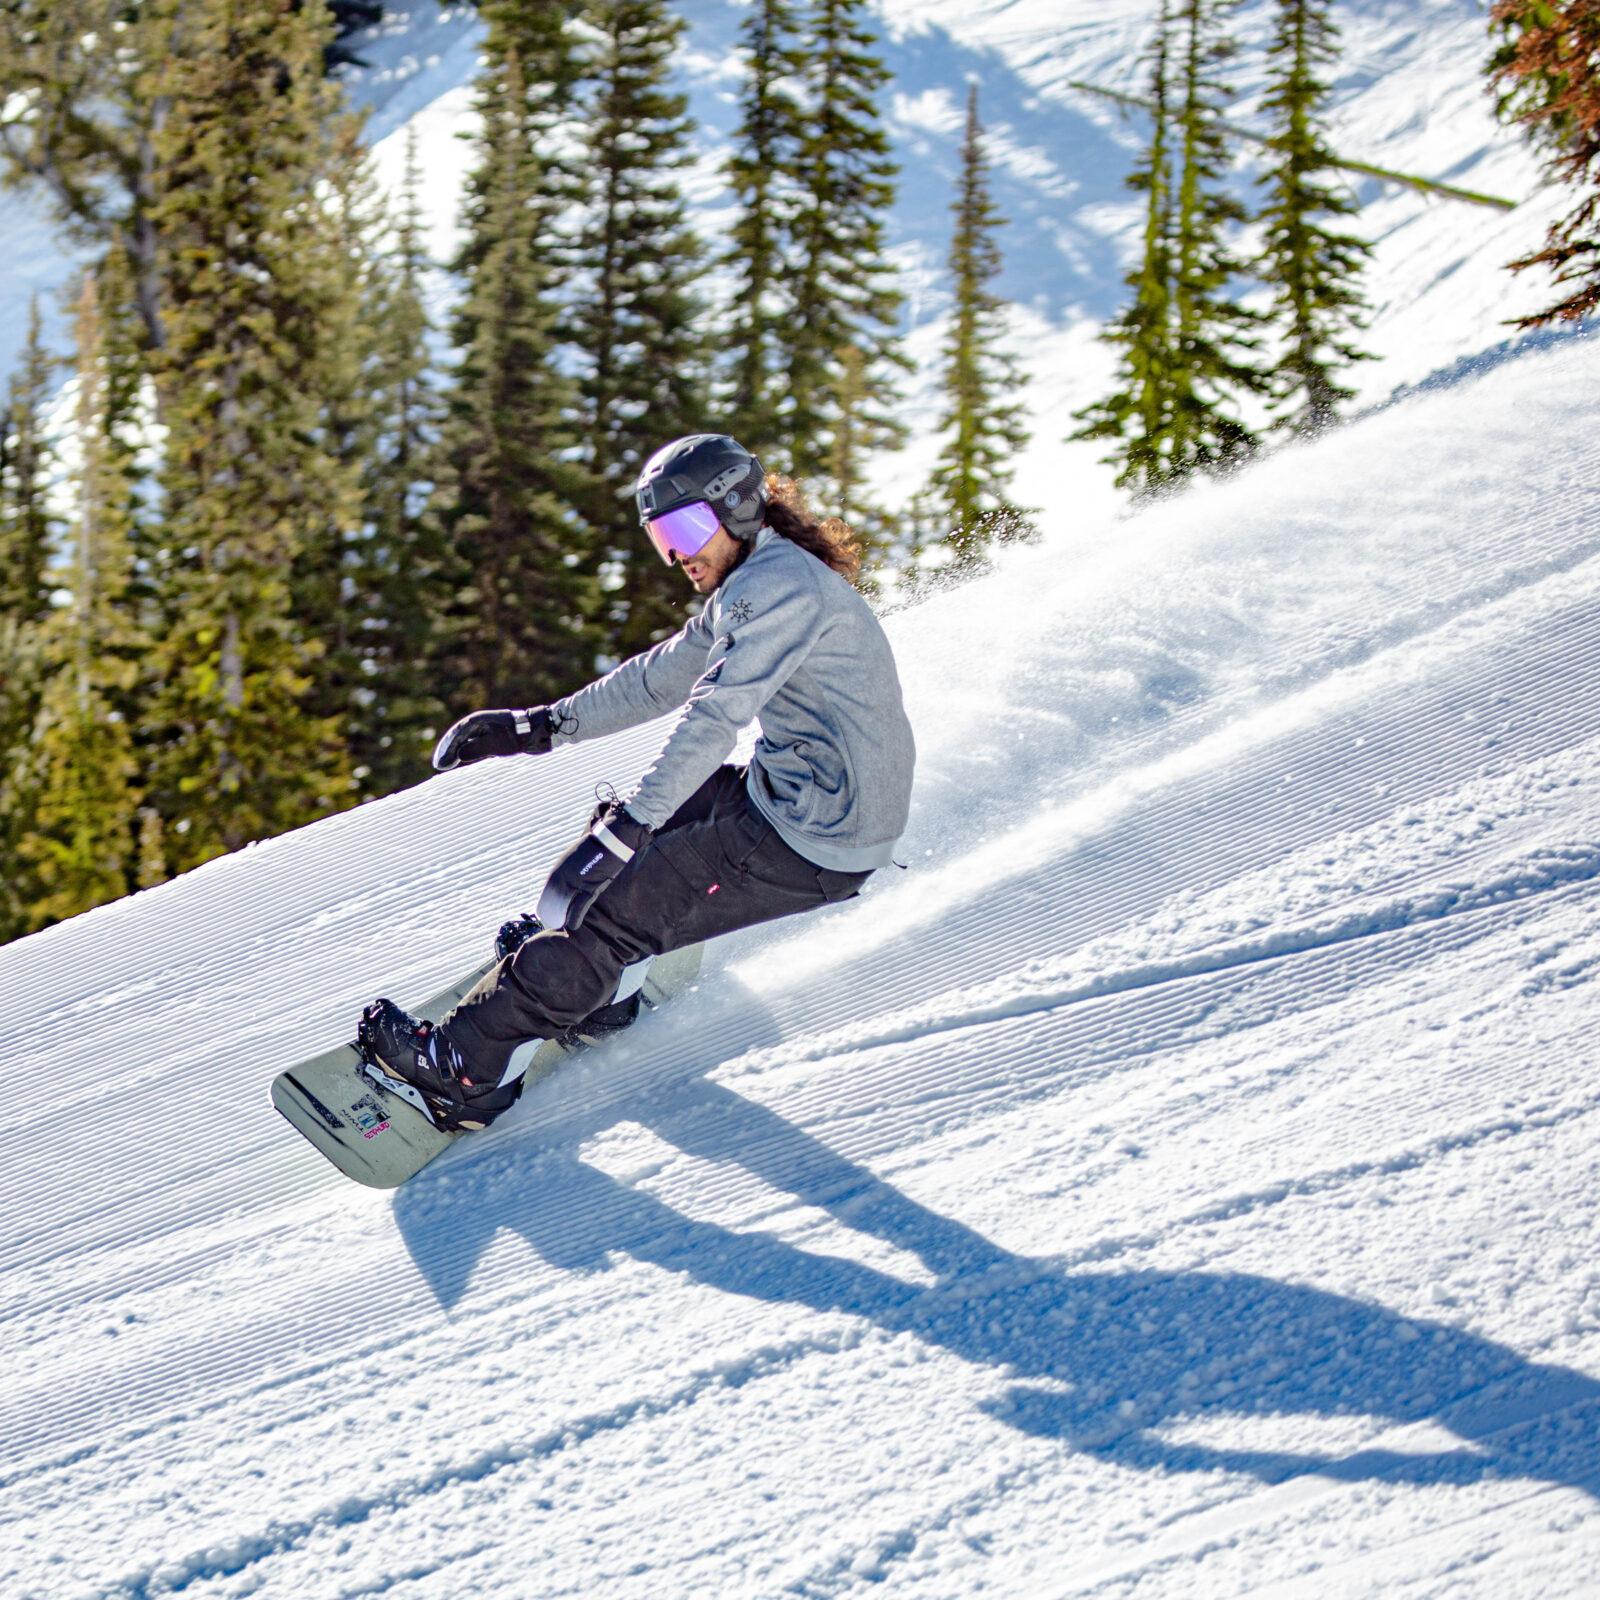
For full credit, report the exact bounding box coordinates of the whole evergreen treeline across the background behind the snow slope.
[0,0,1600,939]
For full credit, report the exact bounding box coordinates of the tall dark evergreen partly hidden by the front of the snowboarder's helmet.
[570,0,709,659]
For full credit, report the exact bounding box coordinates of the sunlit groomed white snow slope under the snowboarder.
[0,339,1600,1600]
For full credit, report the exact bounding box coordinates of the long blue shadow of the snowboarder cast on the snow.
[395,966,1600,1498]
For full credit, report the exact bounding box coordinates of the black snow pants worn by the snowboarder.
[442,766,872,1080]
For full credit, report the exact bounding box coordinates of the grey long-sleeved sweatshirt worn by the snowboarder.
[550,528,917,872]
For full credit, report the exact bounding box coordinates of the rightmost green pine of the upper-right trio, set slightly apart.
[1258,0,1371,435]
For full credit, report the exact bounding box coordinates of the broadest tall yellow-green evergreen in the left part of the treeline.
[149,0,354,870]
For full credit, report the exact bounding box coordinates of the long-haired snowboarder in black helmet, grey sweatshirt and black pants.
[358,434,915,1128]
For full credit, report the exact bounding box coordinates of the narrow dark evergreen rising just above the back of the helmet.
[723,0,805,469]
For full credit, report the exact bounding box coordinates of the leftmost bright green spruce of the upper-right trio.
[1070,0,1178,498]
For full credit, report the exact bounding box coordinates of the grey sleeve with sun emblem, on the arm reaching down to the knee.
[626,566,821,827]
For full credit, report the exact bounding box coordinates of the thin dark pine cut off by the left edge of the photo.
[0,301,56,942]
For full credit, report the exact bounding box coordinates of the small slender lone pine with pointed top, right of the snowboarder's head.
[931,83,1027,560]
